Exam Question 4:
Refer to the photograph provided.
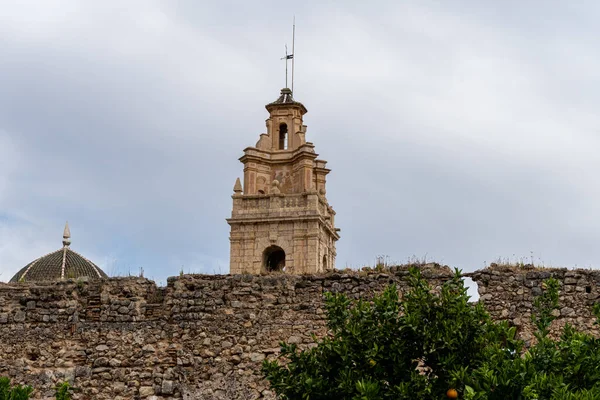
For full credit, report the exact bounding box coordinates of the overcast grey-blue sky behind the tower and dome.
[0,0,600,294]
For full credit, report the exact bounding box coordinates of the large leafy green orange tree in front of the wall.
[262,269,600,400]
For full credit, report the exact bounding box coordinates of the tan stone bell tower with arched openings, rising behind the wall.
[227,88,340,274]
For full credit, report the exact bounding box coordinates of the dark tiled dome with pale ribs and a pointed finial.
[10,224,108,282]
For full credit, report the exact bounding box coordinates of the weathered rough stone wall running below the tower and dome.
[0,266,597,399]
